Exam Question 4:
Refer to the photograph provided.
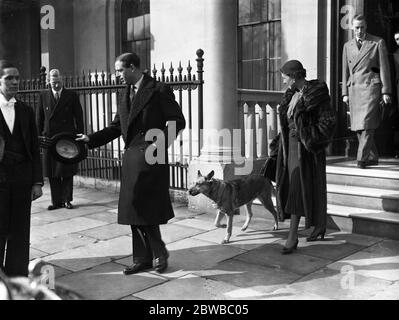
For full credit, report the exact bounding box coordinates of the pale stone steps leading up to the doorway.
[255,159,399,240]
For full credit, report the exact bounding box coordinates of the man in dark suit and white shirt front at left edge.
[0,60,43,276]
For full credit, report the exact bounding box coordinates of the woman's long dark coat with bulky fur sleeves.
[271,80,336,228]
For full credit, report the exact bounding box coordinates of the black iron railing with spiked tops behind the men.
[18,49,204,190]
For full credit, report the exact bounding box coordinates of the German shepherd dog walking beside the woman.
[189,170,278,244]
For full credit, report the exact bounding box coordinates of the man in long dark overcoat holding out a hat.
[77,53,185,274]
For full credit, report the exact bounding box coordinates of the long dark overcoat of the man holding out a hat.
[89,75,185,225]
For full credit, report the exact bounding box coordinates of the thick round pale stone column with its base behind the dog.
[188,0,252,212]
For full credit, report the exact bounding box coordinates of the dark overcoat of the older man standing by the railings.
[36,88,84,178]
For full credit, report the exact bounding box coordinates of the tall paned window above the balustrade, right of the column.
[238,0,281,91]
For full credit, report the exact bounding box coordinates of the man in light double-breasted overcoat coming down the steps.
[342,15,392,169]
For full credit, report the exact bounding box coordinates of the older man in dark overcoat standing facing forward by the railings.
[36,69,84,210]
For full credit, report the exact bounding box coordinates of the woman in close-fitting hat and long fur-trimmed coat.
[276,60,336,254]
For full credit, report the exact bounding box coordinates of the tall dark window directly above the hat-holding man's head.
[121,0,151,70]
